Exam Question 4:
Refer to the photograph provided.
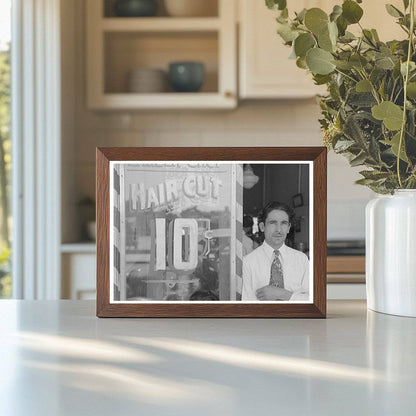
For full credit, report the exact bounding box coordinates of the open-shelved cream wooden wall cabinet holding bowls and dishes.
[86,0,237,109]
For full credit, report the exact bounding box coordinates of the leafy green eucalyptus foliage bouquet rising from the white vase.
[266,0,416,194]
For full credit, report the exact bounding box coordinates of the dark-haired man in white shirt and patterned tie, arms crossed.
[242,202,309,301]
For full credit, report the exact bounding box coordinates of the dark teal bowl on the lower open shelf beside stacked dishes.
[169,62,205,92]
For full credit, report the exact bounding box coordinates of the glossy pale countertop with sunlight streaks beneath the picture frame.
[0,300,416,416]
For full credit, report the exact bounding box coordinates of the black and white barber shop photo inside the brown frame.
[110,161,313,303]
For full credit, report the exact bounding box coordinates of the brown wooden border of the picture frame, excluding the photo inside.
[96,147,327,318]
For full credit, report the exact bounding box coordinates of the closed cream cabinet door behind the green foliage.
[239,0,404,99]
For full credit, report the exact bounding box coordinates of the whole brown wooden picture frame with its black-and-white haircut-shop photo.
[96,147,327,318]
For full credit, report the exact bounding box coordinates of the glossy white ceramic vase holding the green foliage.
[366,189,416,317]
